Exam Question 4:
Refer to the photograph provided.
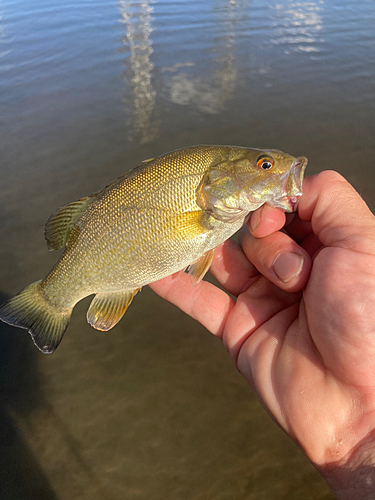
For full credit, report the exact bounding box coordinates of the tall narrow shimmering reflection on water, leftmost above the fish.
[119,0,159,143]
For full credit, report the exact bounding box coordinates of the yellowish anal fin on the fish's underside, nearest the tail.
[86,288,140,332]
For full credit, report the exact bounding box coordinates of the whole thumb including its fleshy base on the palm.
[298,171,375,384]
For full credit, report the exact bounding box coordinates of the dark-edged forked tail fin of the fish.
[0,281,72,354]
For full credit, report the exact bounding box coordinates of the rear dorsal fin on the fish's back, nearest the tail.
[44,195,97,250]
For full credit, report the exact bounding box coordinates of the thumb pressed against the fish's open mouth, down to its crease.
[298,171,375,255]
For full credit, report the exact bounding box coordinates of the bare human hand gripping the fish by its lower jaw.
[151,172,375,499]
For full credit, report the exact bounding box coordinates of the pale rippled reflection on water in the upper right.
[271,0,324,54]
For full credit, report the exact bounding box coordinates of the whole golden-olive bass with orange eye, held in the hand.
[0,145,307,354]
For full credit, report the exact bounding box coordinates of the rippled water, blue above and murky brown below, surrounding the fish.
[0,0,375,500]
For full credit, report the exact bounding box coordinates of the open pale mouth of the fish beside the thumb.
[275,156,307,212]
